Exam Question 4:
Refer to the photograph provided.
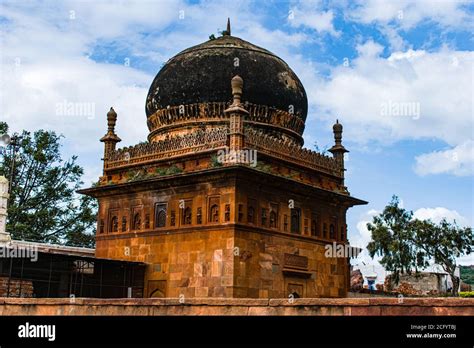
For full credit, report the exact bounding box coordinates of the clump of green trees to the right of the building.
[367,196,474,295]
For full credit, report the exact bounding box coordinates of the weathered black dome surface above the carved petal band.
[146,35,308,121]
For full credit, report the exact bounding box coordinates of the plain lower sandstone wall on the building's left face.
[98,227,234,298]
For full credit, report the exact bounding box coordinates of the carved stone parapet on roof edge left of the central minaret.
[105,127,228,169]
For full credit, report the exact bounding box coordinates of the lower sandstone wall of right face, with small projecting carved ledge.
[234,229,349,298]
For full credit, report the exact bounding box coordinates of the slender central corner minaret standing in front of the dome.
[224,75,249,152]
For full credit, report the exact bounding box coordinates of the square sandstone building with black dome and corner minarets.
[80,24,366,298]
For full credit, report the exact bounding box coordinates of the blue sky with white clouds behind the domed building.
[0,0,474,274]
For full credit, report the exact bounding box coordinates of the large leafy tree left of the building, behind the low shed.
[0,122,97,247]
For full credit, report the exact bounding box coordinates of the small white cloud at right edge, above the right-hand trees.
[415,140,474,176]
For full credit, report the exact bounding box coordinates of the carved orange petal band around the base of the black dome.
[148,102,304,135]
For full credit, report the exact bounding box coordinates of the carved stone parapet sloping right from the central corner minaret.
[245,127,343,177]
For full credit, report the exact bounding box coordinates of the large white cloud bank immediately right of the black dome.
[310,41,474,175]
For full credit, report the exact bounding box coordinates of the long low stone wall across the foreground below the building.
[0,298,474,316]
